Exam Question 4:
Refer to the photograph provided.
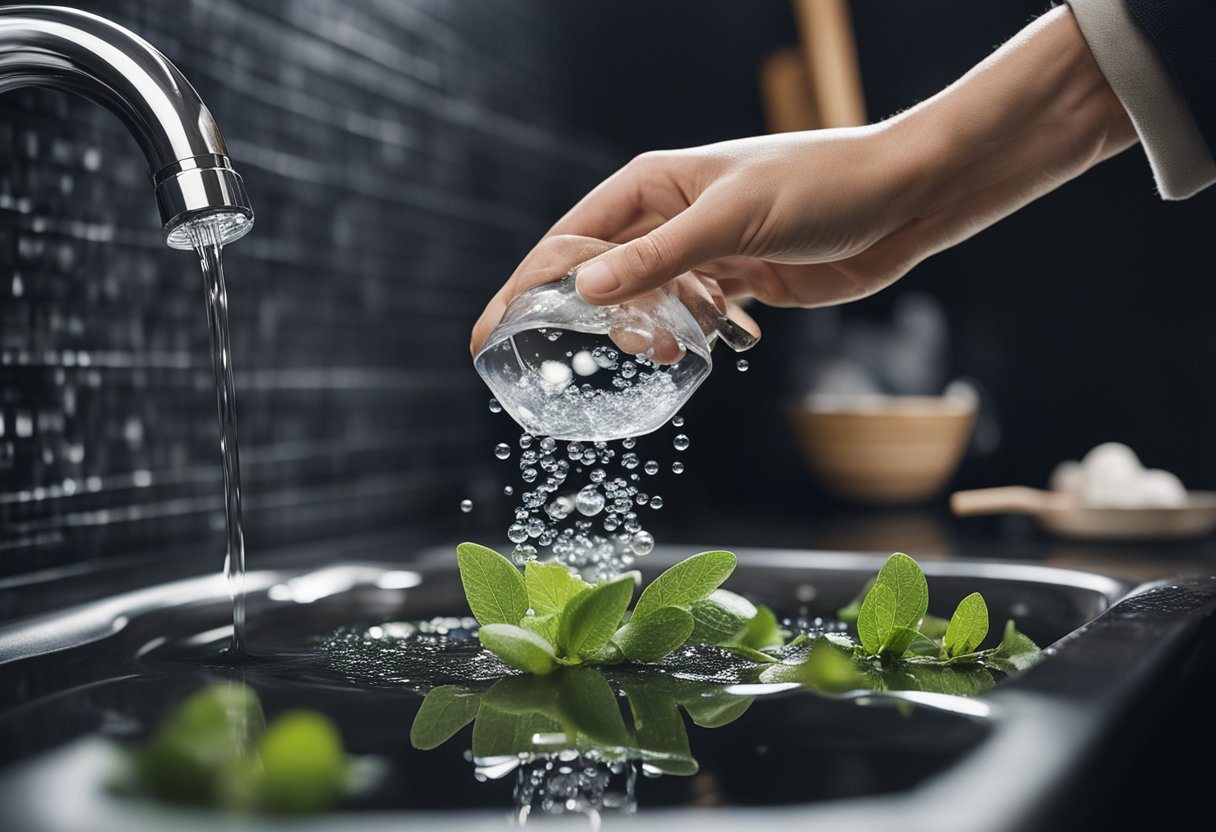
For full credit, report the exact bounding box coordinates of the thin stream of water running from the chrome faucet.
[186,218,244,658]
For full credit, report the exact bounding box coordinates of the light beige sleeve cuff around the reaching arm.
[1068,0,1216,199]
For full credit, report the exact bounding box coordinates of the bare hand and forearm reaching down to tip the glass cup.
[472,6,1136,353]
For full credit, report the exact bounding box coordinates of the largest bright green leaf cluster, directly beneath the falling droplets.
[456,543,753,676]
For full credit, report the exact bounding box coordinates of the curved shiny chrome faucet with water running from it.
[0,6,253,249]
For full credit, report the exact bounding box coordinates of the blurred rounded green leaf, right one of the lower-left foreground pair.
[257,710,348,813]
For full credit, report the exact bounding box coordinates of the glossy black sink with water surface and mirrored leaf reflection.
[0,547,1216,831]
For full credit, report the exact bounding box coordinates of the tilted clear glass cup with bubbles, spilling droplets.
[473,275,715,442]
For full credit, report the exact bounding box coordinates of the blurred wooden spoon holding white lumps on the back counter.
[950,485,1216,540]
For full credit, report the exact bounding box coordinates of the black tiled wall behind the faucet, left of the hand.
[0,0,613,608]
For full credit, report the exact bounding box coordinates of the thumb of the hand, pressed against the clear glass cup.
[575,206,730,305]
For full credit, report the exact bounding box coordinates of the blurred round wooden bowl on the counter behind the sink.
[789,395,975,504]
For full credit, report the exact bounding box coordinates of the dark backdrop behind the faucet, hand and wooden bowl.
[0,0,1216,615]
